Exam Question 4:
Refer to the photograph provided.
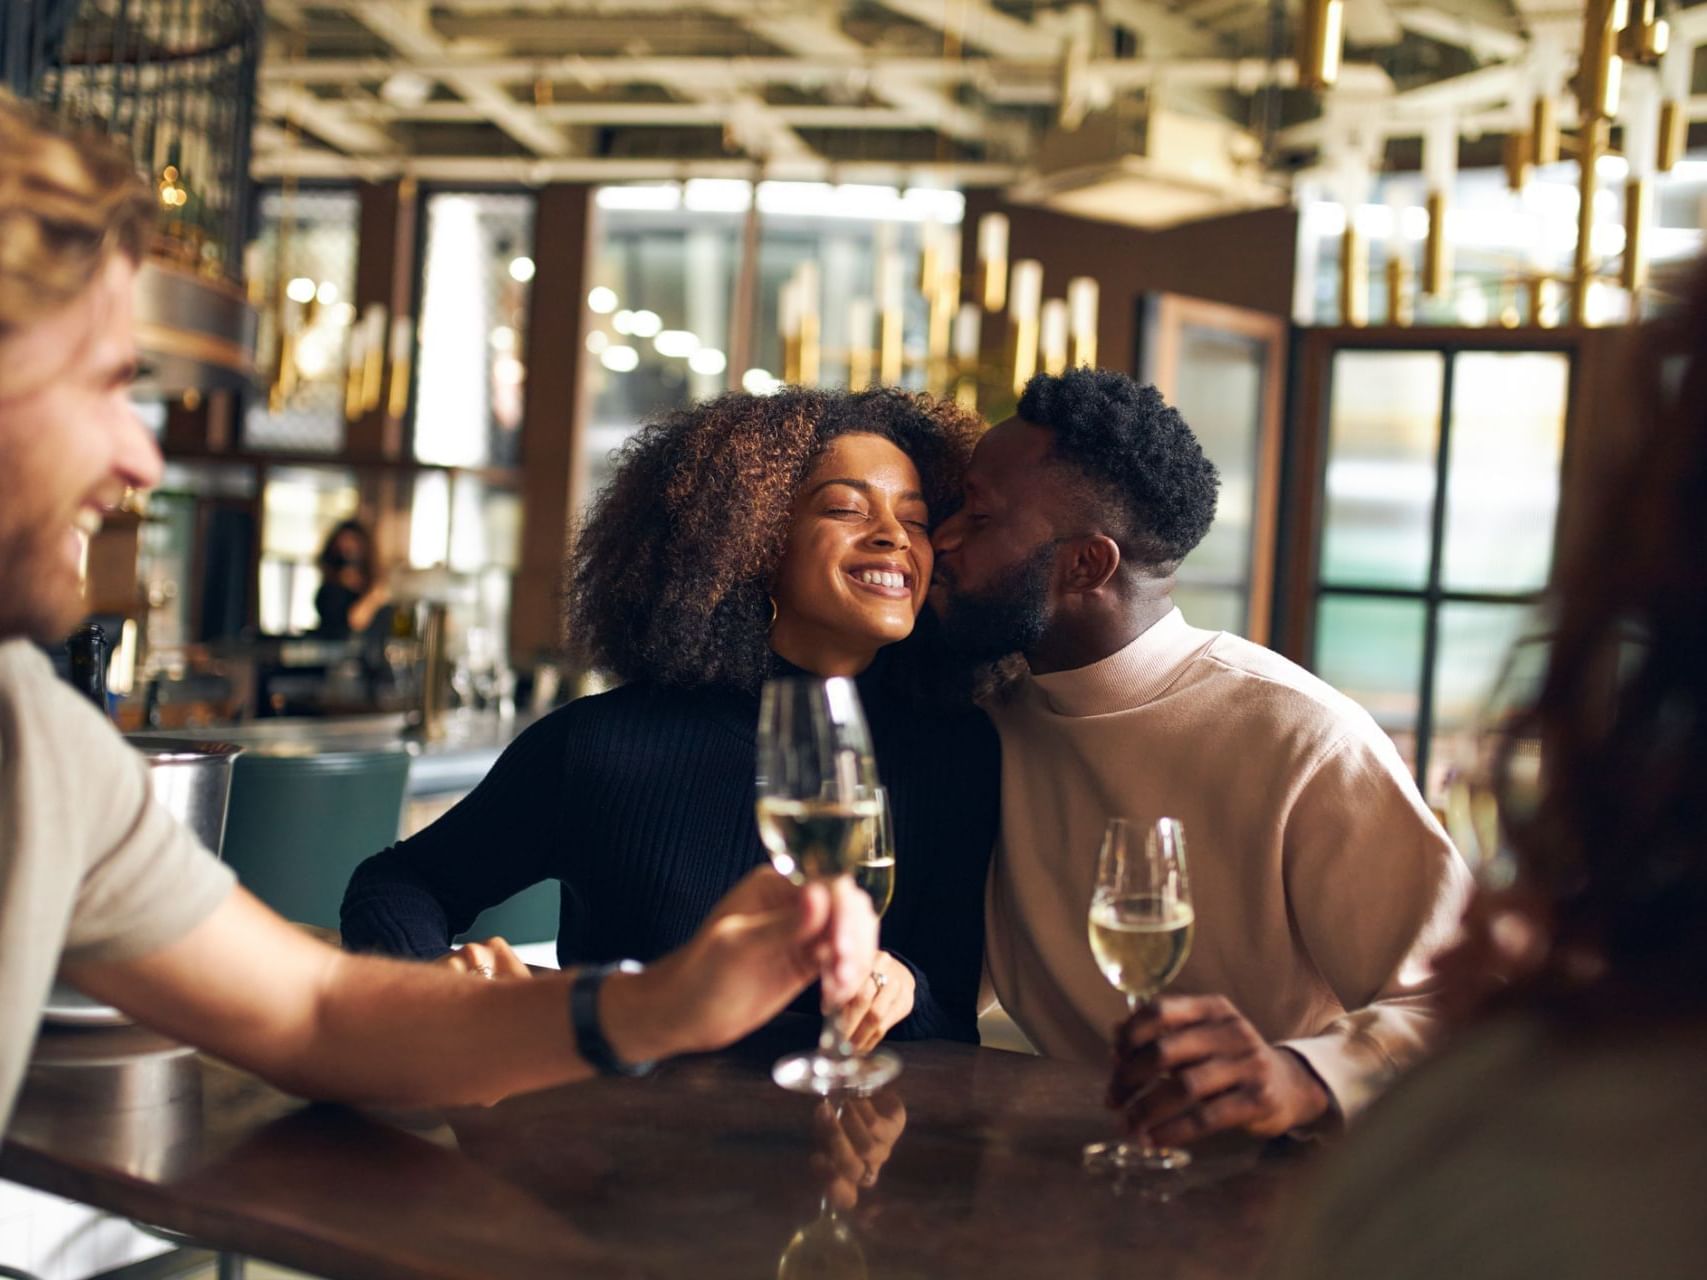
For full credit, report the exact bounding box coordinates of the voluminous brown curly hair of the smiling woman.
[568,387,980,689]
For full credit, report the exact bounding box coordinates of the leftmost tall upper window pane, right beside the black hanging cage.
[242,191,357,454]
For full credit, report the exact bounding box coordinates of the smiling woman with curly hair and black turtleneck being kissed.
[341,387,1000,1050]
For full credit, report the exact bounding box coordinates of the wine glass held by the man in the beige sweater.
[1084,817,1197,1172]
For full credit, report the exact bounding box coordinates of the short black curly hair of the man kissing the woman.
[1019,369,1221,572]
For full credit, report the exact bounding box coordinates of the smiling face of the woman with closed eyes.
[770,432,932,676]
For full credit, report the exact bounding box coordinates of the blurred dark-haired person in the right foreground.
[1279,266,1707,1280]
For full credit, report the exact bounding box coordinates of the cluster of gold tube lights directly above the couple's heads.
[778,213,1101,410]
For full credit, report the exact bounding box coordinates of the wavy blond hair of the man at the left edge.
[0,90,155,338]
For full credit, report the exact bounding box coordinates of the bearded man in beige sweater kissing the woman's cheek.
[932,369,1468,1145]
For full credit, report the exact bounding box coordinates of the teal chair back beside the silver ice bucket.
[224,744,413,932]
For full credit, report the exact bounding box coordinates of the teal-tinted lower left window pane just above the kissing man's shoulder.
[1314,596,1427,765]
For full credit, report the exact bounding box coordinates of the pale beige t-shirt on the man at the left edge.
[0,640,234,1133]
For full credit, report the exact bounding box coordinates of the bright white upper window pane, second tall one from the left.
[415,191,534,466]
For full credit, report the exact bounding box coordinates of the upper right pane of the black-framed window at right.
[1441,352,1570,592]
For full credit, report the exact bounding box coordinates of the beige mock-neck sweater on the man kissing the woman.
[987,609,1470,1116]
